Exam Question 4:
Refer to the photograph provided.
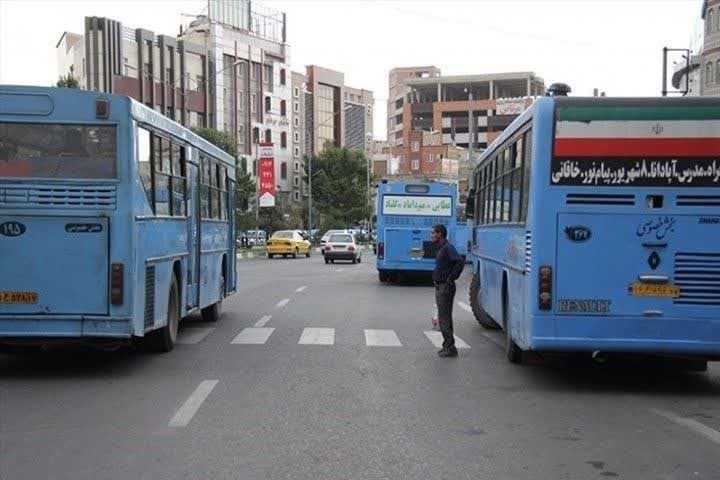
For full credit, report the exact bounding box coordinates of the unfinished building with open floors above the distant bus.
[389,67,545,176]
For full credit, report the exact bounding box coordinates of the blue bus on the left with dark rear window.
[0,86,236,352]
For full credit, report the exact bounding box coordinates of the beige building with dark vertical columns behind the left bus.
[56,17,215,127]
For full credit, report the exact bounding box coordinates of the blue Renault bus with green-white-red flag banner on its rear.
[466,95,720,369]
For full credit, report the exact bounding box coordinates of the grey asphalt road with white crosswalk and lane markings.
[0,255,720,480]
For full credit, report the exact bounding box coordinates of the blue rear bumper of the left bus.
[0,315,133,343]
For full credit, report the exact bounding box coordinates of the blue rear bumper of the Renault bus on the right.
[530,317,720,360]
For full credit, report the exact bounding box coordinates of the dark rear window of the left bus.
[0,123,117,179]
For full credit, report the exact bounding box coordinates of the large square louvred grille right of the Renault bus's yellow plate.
[674,252,720,305]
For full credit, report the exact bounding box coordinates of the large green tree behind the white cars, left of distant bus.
[304,148,373,229]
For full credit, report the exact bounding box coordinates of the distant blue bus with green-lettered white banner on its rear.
[376,181,457,282]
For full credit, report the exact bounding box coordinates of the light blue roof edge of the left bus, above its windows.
[0,85,235,171]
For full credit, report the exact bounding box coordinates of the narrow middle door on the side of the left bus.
[186,147,200,309]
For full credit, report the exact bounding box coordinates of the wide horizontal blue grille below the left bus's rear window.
[0,185,117,210]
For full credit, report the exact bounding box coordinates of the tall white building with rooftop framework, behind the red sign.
[179,0,293,197]
